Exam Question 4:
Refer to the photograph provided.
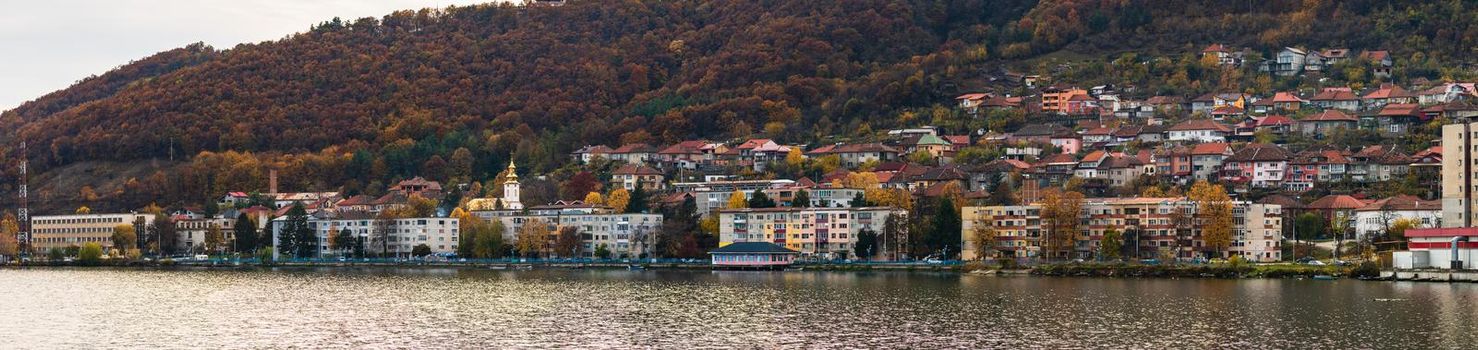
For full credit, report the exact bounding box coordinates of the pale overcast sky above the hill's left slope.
[0,0,492,111]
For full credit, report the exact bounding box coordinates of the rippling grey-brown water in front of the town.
[0,269,1478,349]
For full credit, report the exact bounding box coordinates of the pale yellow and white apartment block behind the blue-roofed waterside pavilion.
[718,207,907,258]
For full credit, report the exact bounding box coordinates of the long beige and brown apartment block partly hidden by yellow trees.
[961,198,1283,261]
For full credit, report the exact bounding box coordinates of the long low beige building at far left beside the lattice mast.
[31,214,154,253]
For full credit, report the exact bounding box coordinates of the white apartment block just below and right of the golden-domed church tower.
[471,204,662,257]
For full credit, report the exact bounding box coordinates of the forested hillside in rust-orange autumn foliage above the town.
[0,0,1478,211]
